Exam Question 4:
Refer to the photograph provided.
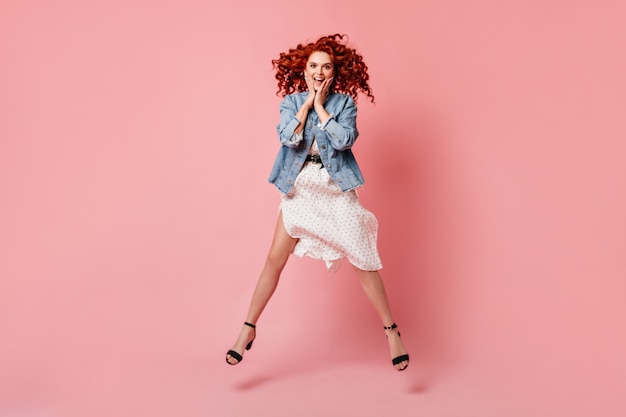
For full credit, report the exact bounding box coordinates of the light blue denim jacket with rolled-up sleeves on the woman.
[269,92,364,194]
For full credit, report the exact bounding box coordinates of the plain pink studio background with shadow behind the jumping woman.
[0,0,626,417]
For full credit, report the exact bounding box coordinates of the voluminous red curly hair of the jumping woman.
[272,34,374,103]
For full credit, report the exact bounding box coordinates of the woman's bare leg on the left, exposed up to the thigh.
[226,211,298,365]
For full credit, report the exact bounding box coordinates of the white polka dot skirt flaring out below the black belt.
[281,162,382,271]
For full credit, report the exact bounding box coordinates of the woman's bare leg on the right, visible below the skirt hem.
[354,267,409,371]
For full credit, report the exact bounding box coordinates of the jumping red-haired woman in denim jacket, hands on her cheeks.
[226,34,409,371]
